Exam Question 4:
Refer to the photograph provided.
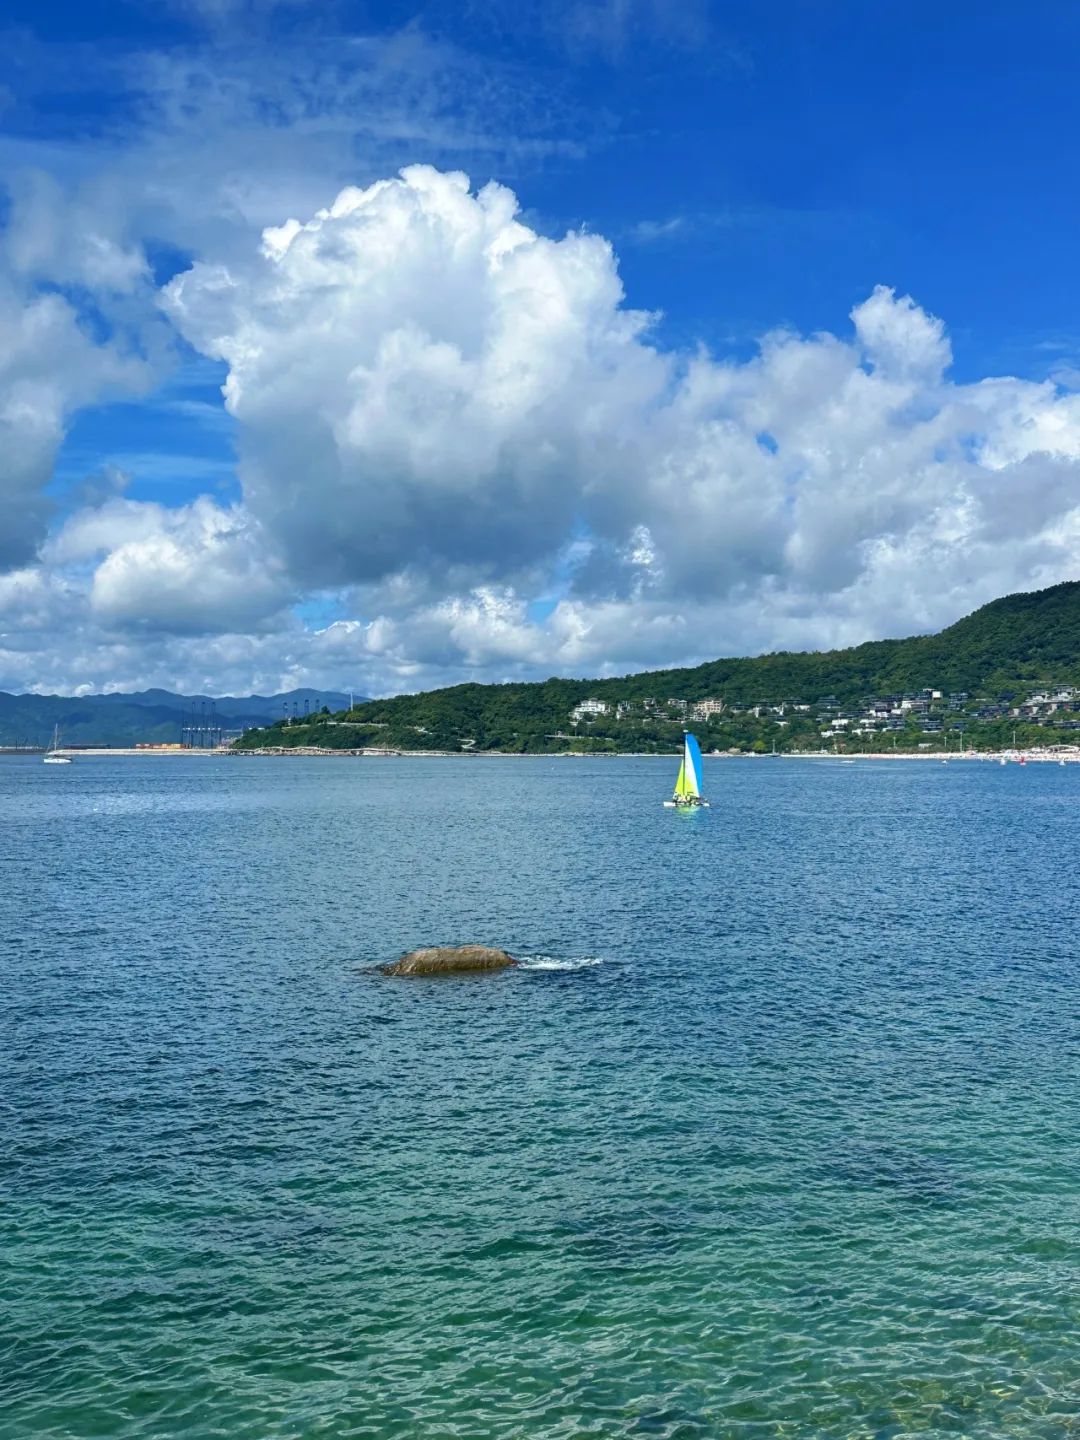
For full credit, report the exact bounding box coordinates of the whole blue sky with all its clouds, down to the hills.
[0,0,1080,694]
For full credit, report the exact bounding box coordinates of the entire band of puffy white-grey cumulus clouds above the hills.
[0,154,1080,693]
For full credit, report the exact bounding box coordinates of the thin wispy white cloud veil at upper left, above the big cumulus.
[0,24,599,289]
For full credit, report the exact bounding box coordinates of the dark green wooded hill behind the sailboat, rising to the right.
[243,582,1080,752]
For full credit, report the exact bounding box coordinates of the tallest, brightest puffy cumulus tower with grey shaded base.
[166,167,668,585]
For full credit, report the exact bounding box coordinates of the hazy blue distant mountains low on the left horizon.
[0,690,364,746]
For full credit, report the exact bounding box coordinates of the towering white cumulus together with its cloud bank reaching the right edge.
[158,167,1080,662]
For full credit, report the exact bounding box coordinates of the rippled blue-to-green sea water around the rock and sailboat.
[0,757,1080,1440]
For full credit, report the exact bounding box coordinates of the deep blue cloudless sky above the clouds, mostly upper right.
[14,0,1080,360]
